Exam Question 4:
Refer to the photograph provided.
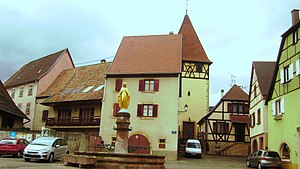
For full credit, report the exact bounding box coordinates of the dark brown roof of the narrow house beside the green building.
[253,62,276,96]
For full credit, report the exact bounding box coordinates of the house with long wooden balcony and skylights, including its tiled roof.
[34,62,111,135]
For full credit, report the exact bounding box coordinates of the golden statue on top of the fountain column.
[118,82,130,112]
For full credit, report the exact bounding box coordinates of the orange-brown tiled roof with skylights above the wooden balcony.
[38,63,111,104]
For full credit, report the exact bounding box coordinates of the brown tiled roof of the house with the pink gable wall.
[4,49,73,88]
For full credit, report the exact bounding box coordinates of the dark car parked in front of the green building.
[246,150,282,169]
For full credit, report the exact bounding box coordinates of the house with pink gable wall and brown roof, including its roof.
[4,49,74,129]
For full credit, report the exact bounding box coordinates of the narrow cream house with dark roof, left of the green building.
[249,62,275,152]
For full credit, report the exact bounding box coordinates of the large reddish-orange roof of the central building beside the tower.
[107,34,181,75]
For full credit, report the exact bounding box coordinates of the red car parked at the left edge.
[0,138,29,157]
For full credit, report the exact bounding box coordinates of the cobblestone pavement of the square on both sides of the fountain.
[0,155,247,169]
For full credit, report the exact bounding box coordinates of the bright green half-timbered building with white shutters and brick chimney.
[267,10,300,169]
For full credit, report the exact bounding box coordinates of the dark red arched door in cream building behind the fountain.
[128,134,150,154]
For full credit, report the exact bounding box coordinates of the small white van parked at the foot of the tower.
[185,139,202,158]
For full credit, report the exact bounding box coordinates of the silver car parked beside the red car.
[23,137,69,163]
